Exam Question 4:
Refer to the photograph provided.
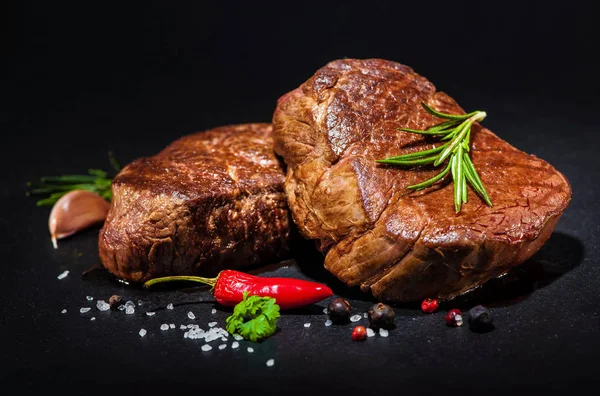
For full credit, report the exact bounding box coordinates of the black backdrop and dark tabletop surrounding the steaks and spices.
[0,1,600,394]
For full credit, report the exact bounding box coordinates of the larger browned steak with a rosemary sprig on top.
[273,59,571,302]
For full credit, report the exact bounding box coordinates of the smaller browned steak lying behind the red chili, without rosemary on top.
[99,124,291,282]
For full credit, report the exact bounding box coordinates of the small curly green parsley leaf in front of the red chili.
[225,292,280,342]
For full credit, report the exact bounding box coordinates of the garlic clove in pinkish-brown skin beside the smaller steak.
[48,190,110,249]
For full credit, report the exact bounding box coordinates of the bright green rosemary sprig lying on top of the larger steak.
[377,102,492,213]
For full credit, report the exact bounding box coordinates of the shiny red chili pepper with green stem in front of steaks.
[144,270,333,309]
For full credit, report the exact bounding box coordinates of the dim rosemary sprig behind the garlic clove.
[26,152,121,206]
